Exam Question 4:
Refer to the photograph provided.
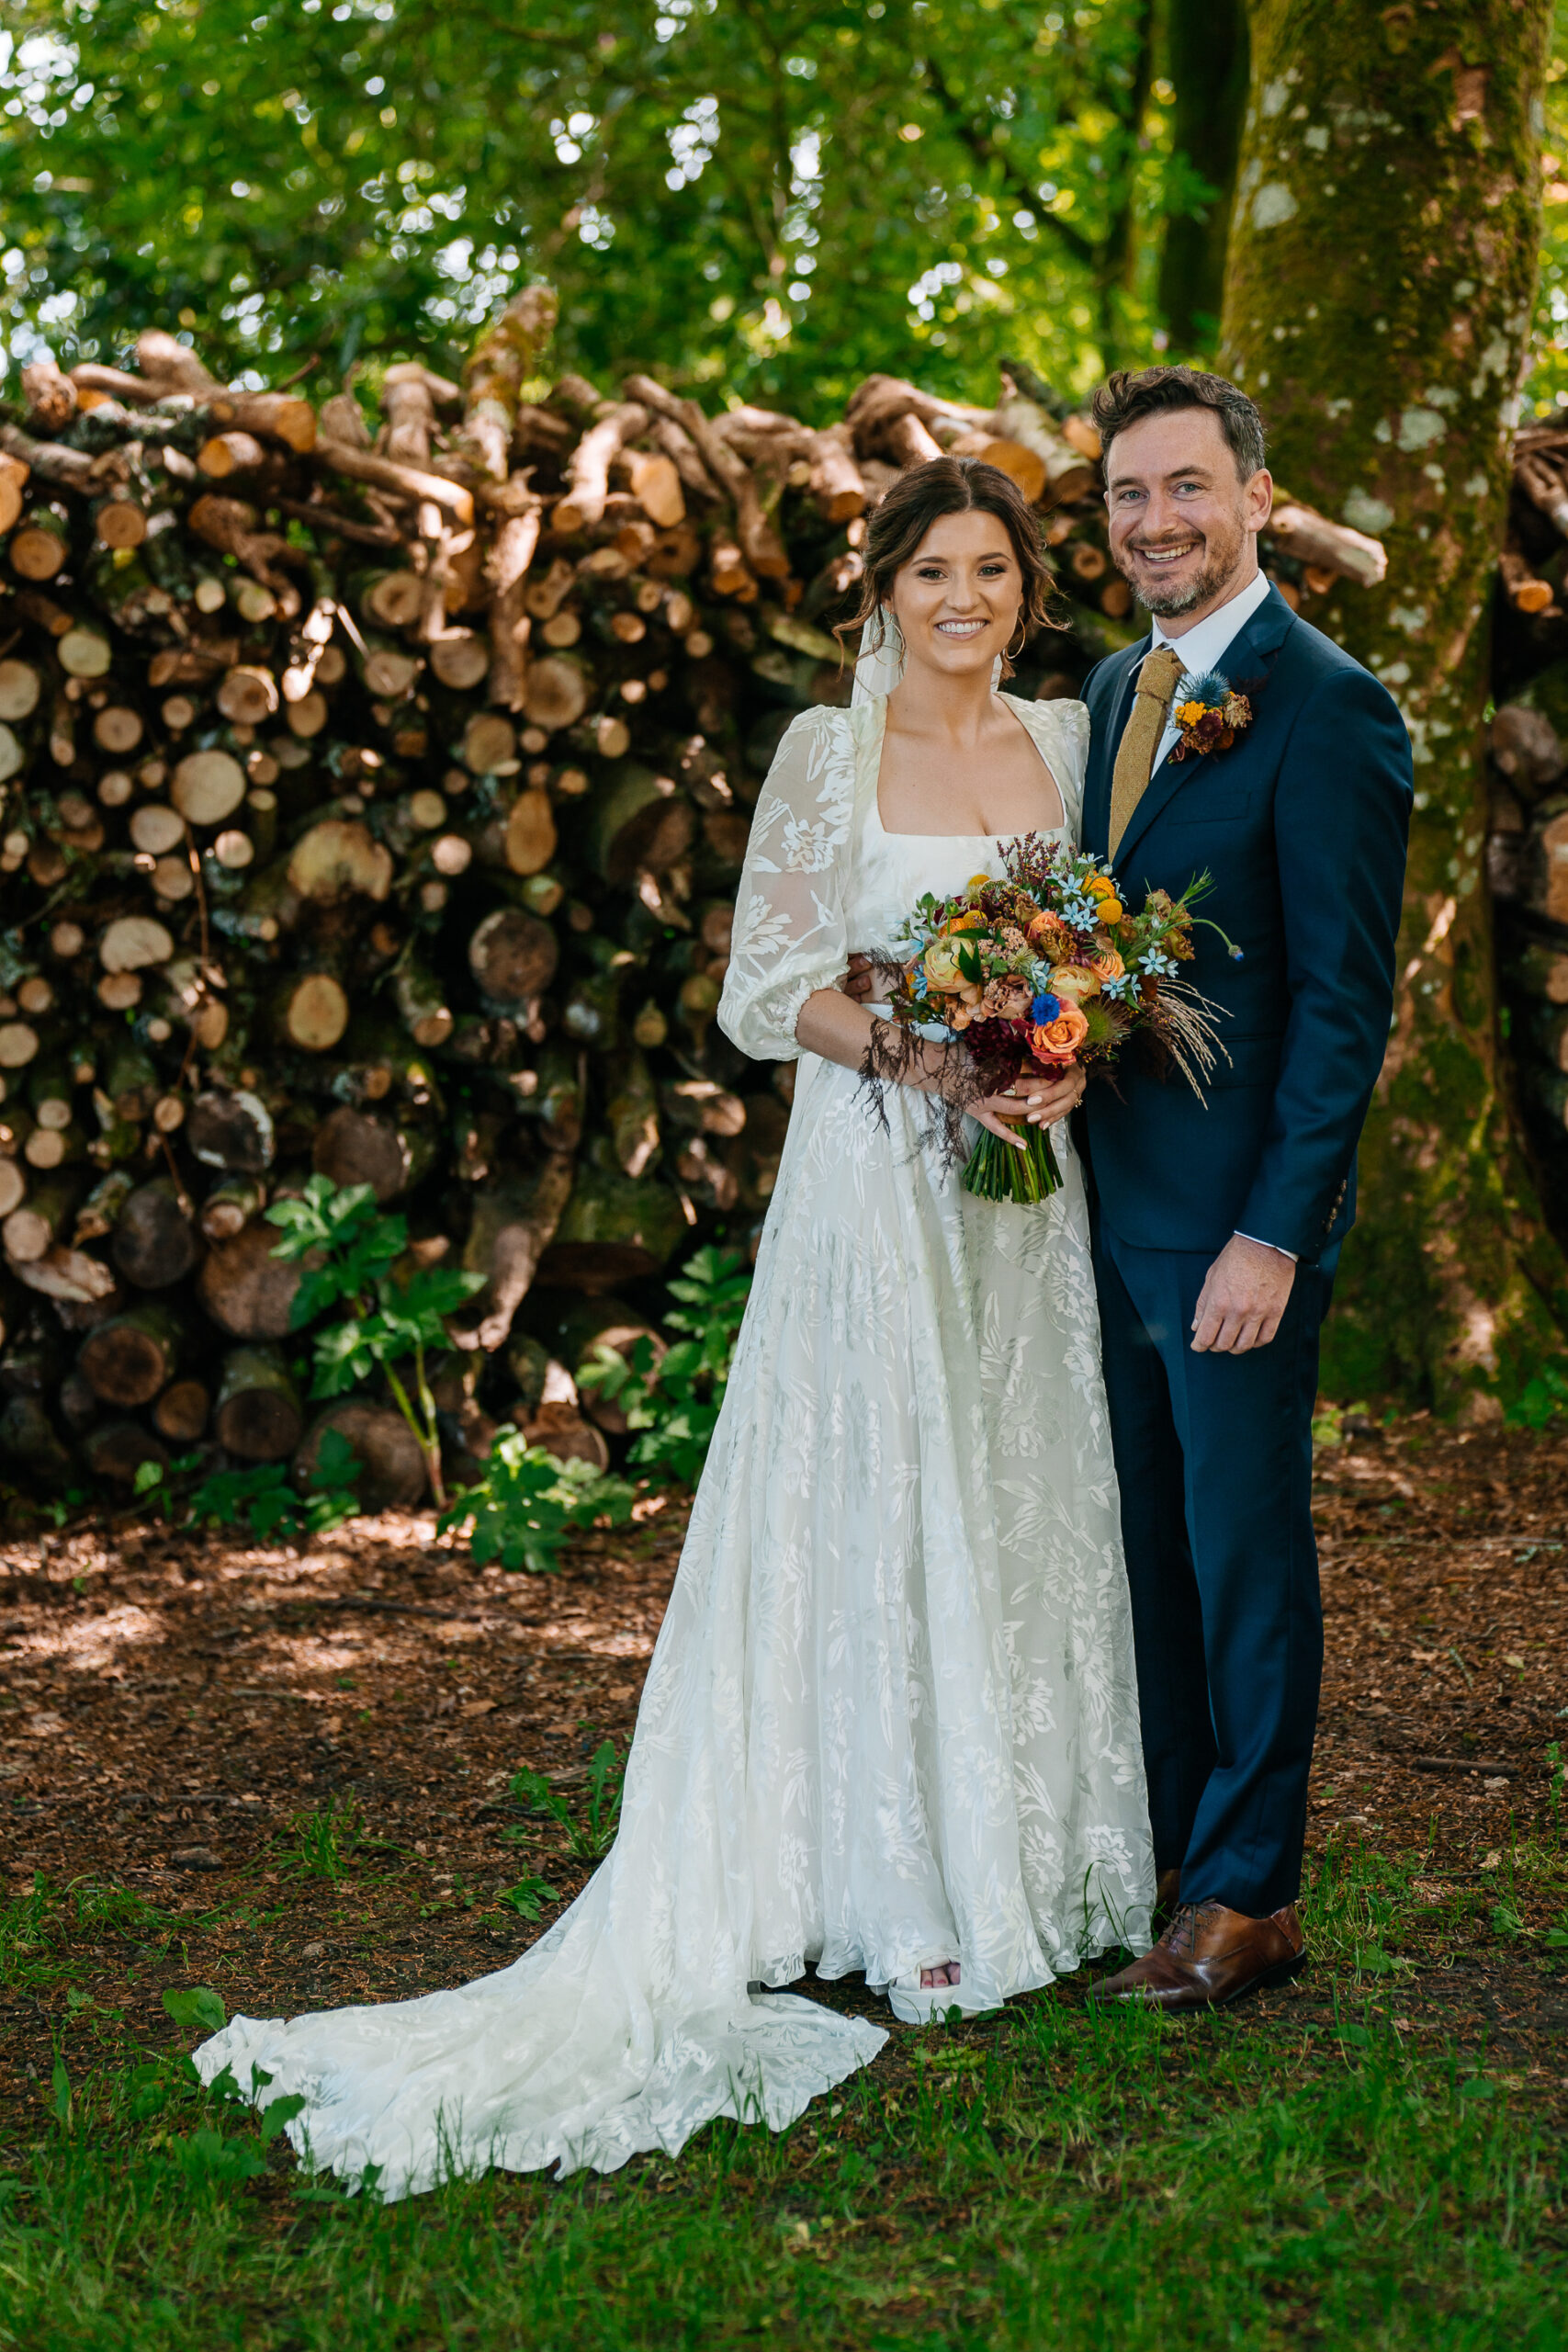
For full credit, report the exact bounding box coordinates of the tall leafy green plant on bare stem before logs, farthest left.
[265,1176,484,1508]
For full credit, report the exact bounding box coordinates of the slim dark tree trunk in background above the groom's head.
[1159,0,1248,357]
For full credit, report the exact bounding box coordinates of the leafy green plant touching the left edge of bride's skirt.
[579,1247,752,1487]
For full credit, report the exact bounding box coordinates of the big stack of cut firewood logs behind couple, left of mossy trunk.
[0,303,1382,1496]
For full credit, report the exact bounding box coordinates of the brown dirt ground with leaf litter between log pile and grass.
[0,1416,1568,2109]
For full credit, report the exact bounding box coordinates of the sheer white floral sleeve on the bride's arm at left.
[719,708,856,1061]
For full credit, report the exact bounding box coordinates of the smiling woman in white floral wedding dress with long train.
[195,458,1155,2197]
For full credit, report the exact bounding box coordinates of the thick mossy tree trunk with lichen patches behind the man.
[1220,0,1568,1419]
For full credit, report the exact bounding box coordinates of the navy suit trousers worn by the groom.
[1093,1216,1337,1919]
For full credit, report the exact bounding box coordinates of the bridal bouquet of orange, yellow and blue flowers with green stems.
[865,832,1241,1202]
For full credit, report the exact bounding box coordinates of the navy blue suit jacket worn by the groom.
[1084,591,1413,1261]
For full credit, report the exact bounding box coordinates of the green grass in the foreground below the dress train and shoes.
[0,1844,1568,2352]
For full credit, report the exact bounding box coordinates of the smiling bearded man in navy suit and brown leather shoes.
[1081,367,1411,2008]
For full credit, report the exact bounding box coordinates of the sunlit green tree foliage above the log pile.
[0,0,1175,407]
